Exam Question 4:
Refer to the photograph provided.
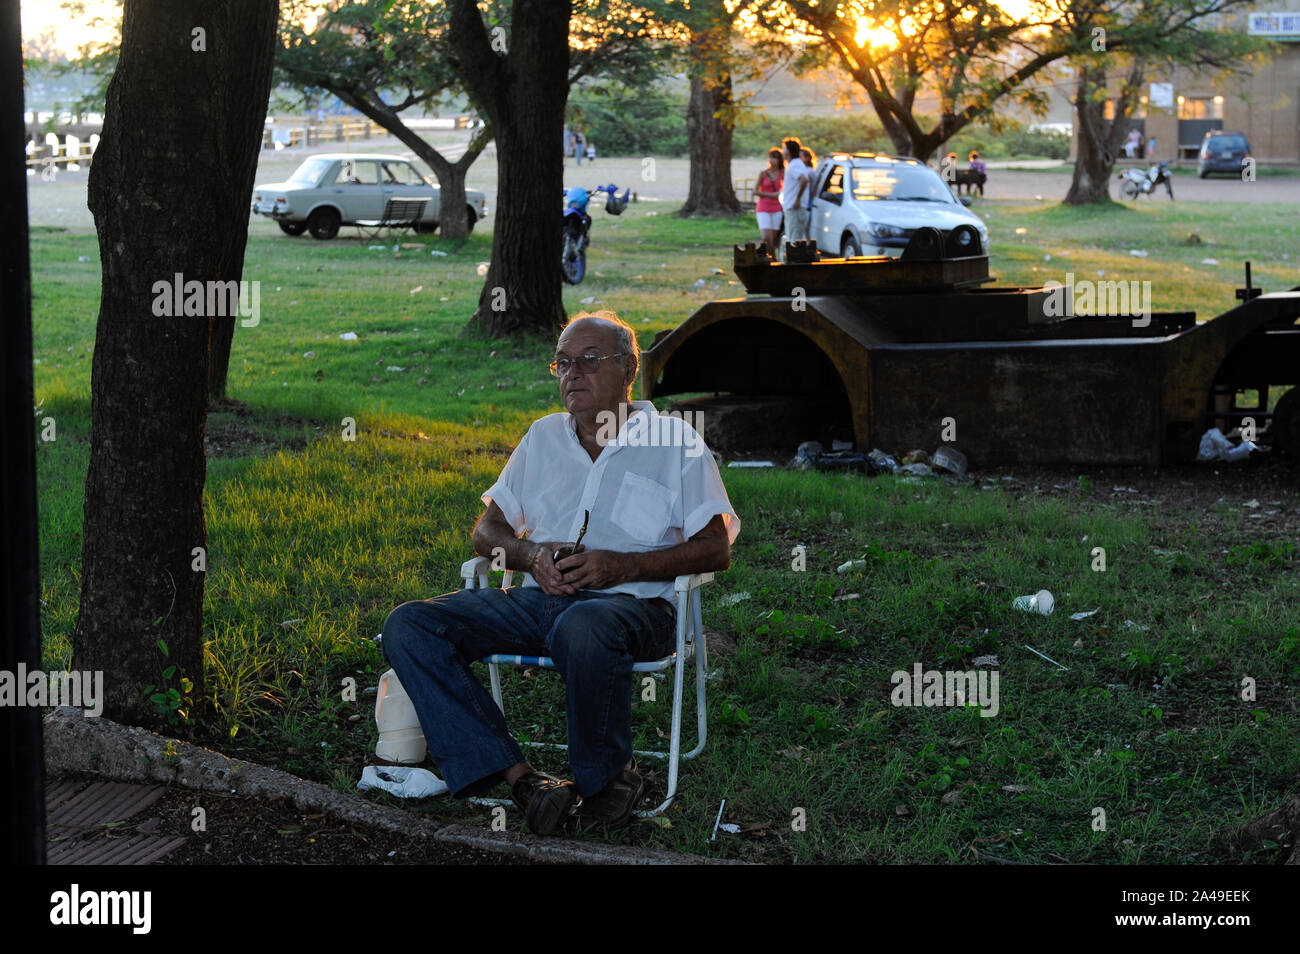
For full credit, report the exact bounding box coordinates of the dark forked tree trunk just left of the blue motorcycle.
[449,0,569,338]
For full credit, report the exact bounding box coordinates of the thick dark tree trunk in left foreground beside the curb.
[73,0,278,725]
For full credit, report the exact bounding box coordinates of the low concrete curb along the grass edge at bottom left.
[44,706,737,864]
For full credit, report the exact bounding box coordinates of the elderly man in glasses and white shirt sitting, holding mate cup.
[384,312,740,834]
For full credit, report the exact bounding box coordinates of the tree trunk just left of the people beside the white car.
[677,39,744,216]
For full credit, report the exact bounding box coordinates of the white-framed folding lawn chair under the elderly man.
[460,556,714,818]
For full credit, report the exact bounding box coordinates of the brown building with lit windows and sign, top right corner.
[1070,0,1300,166]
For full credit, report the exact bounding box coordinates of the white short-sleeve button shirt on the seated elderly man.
[482,400,740,599]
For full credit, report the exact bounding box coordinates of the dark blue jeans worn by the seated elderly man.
[384,586,676,797]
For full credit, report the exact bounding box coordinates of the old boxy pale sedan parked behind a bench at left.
[252,152,488,239]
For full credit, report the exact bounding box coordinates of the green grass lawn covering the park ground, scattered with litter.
[33,194,1300,863]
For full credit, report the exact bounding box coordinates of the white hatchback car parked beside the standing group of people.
[809,152,988,259]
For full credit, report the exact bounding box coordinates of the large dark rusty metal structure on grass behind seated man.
[641,229,1300,465]
